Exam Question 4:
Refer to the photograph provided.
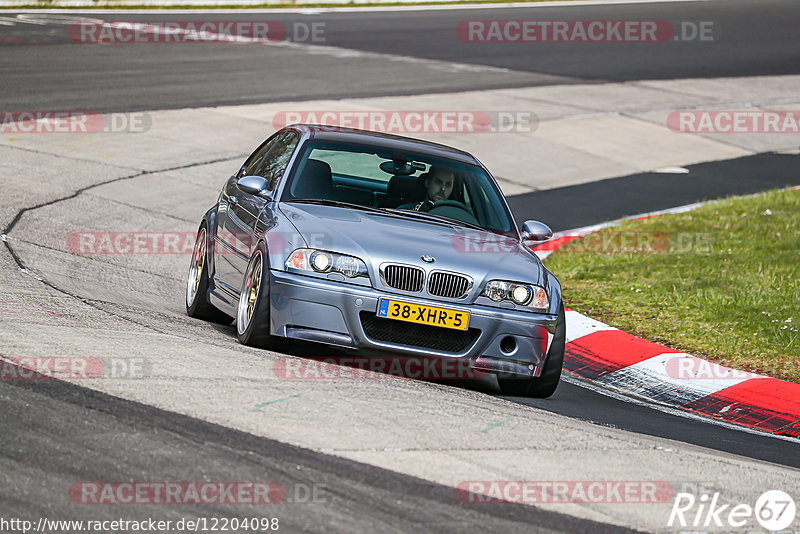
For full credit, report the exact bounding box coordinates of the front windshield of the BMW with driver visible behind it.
[282,141,513,232]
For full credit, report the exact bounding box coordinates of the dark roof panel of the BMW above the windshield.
[287,124,480,165]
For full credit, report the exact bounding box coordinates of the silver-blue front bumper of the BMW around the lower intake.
[270,270,558,377]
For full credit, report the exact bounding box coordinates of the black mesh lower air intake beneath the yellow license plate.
[360,311,481,353]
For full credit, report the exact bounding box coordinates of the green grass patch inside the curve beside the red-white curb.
[545,190,800,382]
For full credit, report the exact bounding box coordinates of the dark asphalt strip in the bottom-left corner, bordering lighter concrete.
[0,364,633,534]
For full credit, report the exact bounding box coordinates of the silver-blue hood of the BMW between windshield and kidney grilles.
[280,203,547,297]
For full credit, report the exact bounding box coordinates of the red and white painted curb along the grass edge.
[535,191,800,439]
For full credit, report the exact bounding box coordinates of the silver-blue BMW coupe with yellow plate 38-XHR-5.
[186,125,565,397]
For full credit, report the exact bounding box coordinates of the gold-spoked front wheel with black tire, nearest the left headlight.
[236,241,274,348]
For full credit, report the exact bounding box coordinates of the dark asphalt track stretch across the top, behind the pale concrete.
[0,0,800,111]
